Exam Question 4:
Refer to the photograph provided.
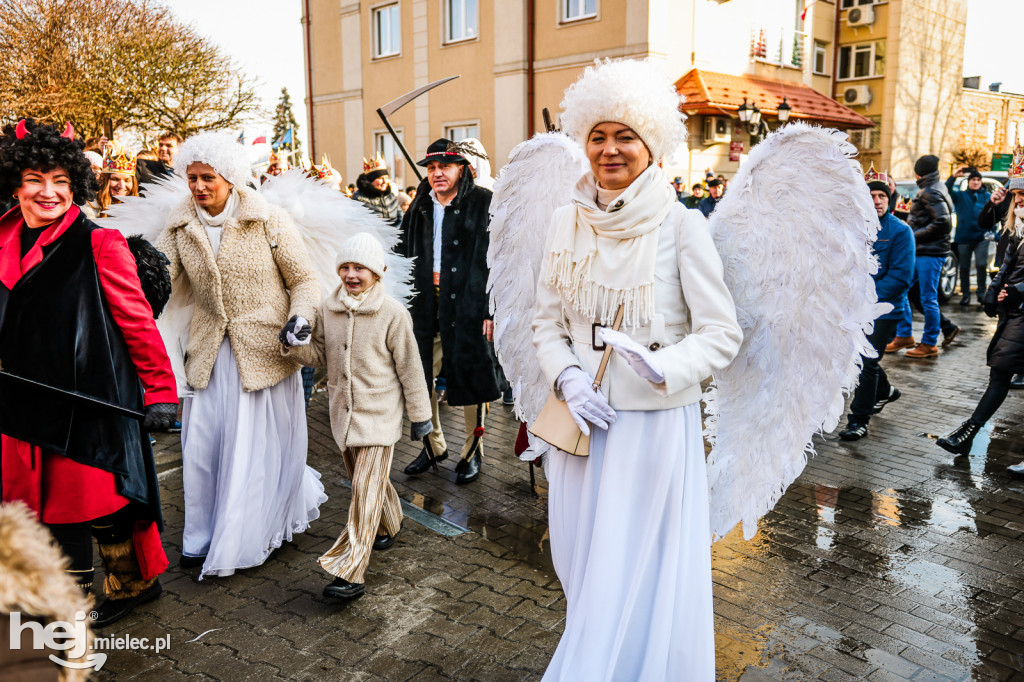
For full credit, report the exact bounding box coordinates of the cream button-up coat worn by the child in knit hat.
[282,285,430,450]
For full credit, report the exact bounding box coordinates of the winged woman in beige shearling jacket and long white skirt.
[101,133,412,578]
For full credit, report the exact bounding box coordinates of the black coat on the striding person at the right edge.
[985,238,1024,374]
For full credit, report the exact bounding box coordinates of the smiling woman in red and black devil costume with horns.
[0,119,177,628]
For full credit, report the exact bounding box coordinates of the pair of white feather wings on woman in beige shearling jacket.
[96,170,413,397]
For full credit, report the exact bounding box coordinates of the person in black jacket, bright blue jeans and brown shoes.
[886,155,959,357]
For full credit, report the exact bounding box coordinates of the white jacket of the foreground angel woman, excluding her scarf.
[534,203,743,411]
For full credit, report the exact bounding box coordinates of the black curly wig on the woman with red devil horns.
[0,119,97,205]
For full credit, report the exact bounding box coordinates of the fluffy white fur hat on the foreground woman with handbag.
[560,59,686,162]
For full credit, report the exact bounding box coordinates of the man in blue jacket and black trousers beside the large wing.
[839,168,915,440]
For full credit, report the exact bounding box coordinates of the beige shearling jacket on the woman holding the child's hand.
[157,187,321,391]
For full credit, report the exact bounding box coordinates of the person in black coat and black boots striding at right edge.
[936,177,1024,466]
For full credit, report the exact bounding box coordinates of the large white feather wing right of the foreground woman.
[705,123,891,540]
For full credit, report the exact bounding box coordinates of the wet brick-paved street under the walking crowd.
[99,306,1024,682]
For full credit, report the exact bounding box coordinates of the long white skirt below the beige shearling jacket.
[181,337,327,577]
